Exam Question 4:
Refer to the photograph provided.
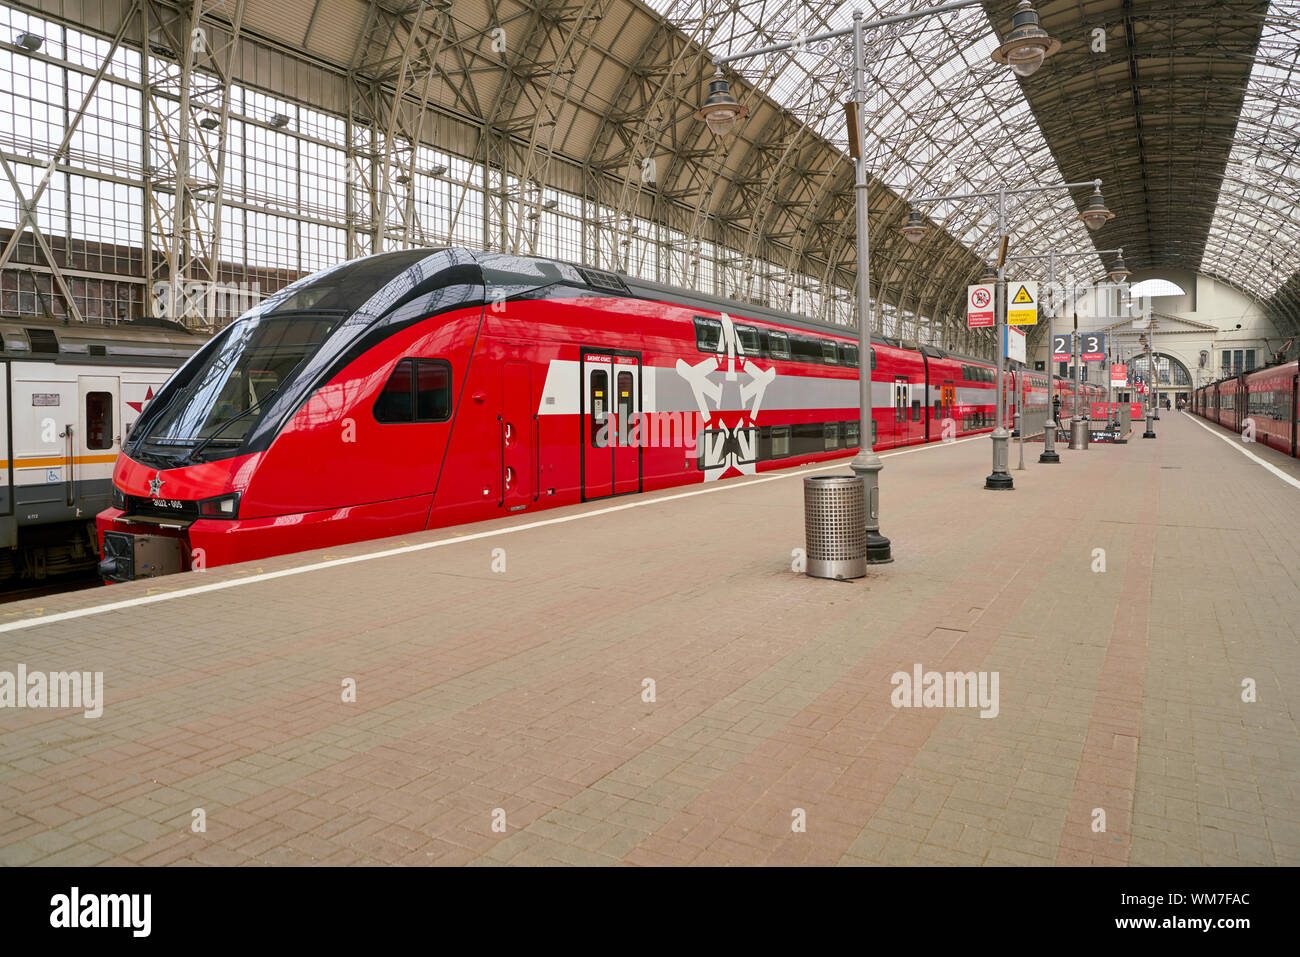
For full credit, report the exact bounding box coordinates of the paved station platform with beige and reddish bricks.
[0,412,1300,865]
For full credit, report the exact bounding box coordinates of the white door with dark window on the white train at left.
[76,376,122,514]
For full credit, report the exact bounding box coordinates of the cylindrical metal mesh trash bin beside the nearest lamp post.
[803,475,867,580]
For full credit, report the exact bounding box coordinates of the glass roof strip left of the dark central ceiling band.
[647,0,1105,281]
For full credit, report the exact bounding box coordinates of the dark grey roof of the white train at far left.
[0,316,207,367]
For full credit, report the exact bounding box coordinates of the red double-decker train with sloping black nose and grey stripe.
[98,248,1086,581]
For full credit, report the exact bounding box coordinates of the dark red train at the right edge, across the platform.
[1192,359,1300,455]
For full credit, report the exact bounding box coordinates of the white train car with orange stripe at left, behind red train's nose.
[0,317,207,585]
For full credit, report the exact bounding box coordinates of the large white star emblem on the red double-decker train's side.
[677,312,776,482]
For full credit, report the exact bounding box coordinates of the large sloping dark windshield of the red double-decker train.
[139,312,342,462]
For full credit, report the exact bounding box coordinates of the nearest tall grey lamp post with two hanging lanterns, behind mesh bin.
[696,0,1061,564]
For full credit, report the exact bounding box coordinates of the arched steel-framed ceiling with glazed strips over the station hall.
[20,0,1300,343]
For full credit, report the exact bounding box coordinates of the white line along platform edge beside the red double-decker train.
[0,434,988,633]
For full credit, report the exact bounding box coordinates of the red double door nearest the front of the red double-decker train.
[581,351,641,501]
